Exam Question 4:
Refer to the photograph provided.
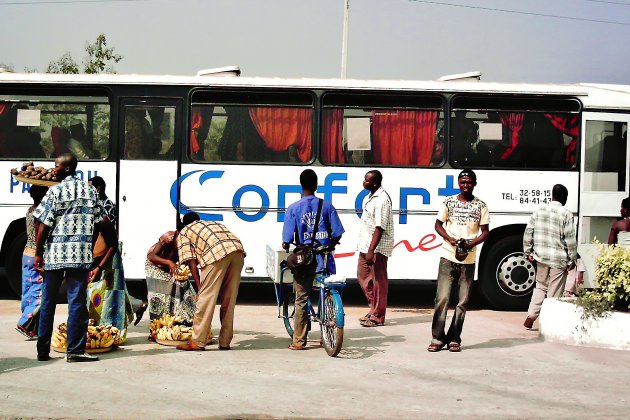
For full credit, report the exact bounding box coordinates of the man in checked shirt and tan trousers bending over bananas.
[177,213,245,351]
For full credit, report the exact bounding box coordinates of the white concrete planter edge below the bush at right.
[539,298,630,351]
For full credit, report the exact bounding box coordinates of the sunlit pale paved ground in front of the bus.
[0,288,630,419]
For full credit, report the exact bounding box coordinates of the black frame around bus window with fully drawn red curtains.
[318,90,448,169]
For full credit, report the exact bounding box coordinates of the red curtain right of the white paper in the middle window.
[372,111,437,166]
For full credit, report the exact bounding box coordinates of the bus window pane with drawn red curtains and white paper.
[322,94,445,167]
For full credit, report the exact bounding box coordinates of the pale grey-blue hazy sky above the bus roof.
[0,0,630,84]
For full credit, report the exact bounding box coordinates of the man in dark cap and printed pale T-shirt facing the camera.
[427,169,490,352]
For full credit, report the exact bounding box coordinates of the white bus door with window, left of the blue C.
[118,99,182,279]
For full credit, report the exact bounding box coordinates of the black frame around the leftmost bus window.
[0,84,118,162]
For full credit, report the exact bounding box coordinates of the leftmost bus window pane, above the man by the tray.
[0,95,110,160]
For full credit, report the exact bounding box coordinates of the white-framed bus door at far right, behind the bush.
[578,112,630,287]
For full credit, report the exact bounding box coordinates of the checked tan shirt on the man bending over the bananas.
[177,220,244,268]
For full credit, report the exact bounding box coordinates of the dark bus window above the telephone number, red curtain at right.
[449,97,580,169]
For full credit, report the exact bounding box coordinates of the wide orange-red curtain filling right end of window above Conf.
[249,108,313,162]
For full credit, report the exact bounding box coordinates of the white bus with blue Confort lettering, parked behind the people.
[0,73,630,309]
